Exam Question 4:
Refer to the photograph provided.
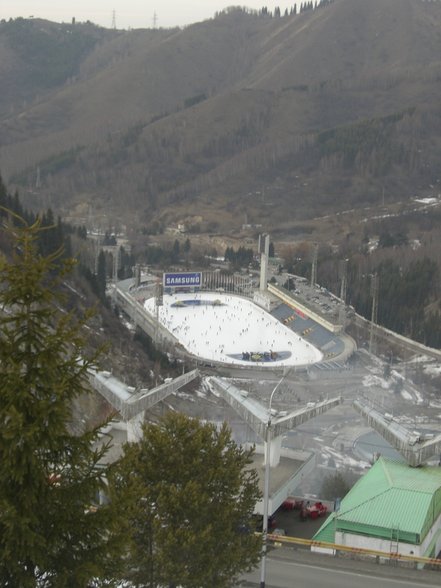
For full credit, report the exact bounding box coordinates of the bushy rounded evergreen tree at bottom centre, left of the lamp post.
[110,413,262,588]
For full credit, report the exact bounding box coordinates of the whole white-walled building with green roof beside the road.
[313,457,441,557]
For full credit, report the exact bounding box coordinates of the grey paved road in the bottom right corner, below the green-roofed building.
[240,553,441,588]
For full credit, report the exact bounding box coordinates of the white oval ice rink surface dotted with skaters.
[144,292,322,367]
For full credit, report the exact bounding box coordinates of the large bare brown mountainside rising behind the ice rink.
[0,0,441,235]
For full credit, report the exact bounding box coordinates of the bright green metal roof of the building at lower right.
[314,457,441,544]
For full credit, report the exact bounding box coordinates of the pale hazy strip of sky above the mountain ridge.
[0,0,300,29]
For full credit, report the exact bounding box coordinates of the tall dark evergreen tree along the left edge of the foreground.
[0,218,124,588]
